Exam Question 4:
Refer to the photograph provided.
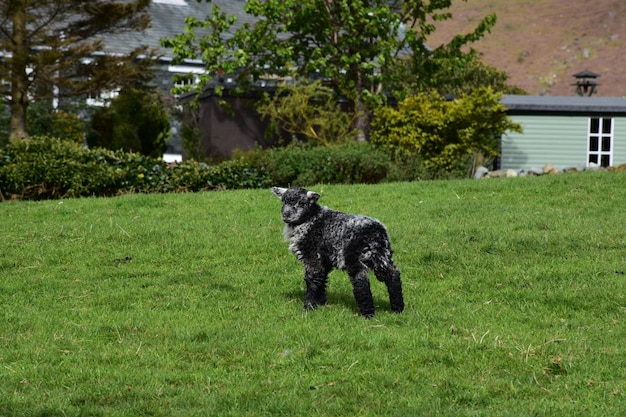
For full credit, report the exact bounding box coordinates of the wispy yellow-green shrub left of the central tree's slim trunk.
[257,80,356,145]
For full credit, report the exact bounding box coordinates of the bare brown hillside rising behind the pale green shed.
[428,0,626,96]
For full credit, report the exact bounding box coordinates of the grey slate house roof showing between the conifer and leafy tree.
[101,0,254,60]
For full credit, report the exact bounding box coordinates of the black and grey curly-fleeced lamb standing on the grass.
[272,187,404,318]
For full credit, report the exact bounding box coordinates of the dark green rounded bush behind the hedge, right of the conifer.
[87,89,170,158]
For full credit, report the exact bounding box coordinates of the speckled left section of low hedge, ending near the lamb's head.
[0,133,269,200]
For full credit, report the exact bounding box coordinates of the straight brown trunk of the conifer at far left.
[9,1,28,139]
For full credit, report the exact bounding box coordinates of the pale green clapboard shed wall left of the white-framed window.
[501,115,588,169]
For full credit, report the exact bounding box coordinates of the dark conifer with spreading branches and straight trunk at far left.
[0,0,154,138]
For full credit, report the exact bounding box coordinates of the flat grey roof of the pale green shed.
[500,95,626,116]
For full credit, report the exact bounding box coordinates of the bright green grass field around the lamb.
[0,172,626,417]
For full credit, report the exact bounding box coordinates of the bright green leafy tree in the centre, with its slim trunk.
[162,0,496,139]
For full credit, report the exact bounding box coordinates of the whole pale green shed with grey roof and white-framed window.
[500,95,626,170]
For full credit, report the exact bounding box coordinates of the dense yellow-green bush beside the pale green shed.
[372,88,521,170]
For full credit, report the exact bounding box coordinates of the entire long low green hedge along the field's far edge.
[0,137,450,200]
